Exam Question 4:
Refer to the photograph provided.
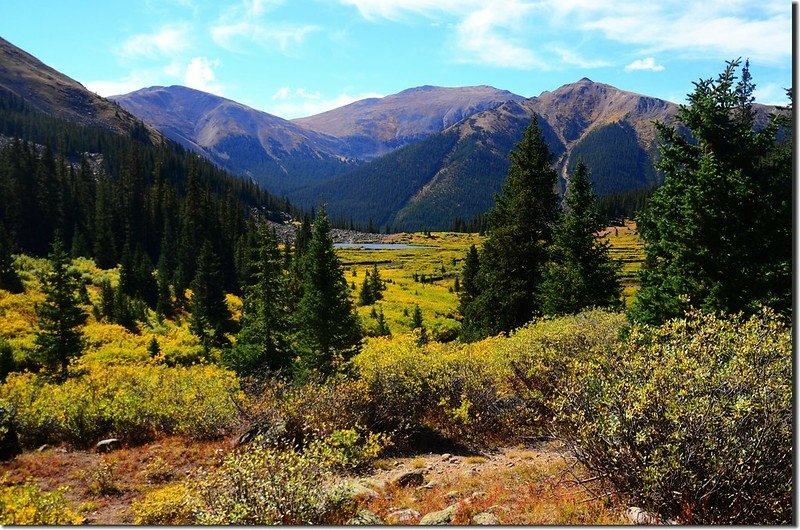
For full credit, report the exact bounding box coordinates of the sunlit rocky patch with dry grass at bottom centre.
[366,447,626,525]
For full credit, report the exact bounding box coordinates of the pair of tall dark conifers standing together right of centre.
[459,117,620,341]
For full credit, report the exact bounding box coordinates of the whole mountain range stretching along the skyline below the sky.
[0,39,770,230]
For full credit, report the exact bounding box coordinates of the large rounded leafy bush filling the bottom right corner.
[553,311,793,524]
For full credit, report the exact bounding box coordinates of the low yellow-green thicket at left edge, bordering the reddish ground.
[0,365,240,447]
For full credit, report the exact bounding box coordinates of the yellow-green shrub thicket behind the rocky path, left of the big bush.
[352,311,625,446]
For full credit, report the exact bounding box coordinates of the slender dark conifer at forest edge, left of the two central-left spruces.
[189,240,230,351]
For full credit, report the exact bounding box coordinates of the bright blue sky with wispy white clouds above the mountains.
[0,0,792,118]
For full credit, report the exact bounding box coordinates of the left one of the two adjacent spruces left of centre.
[224,223,292,375]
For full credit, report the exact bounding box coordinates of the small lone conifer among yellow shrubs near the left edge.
[34,236,88,380]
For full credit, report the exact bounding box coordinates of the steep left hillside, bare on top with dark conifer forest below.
[0,41,288,296]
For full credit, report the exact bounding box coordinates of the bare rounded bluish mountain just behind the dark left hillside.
[111,86,354,194]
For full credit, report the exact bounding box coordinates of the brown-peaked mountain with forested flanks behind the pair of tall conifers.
[297,79,677,230]
